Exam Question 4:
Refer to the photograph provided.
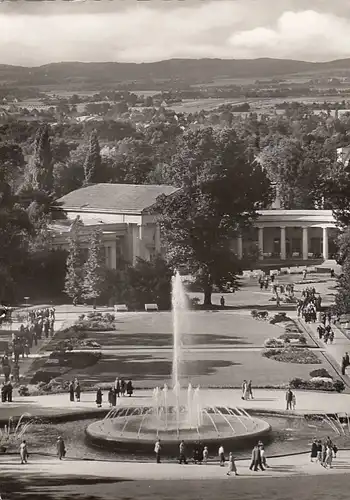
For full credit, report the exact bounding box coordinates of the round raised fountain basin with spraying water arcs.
[86,407,271,451]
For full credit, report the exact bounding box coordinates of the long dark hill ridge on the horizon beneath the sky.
[0,58,350,85]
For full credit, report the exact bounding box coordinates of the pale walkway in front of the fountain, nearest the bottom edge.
[0,450,350,480]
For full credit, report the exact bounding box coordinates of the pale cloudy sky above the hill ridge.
[0,0,350,66]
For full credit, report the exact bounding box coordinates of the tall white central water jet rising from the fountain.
[172,272,188,387]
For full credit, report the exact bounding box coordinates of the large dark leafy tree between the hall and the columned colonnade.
[157,128,272,305]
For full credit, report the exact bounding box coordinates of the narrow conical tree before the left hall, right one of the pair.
[83,229,106,306]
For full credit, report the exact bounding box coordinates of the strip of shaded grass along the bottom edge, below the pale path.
[0,472,349,500]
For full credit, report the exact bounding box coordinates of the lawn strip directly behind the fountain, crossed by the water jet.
[56,351,337,388]
